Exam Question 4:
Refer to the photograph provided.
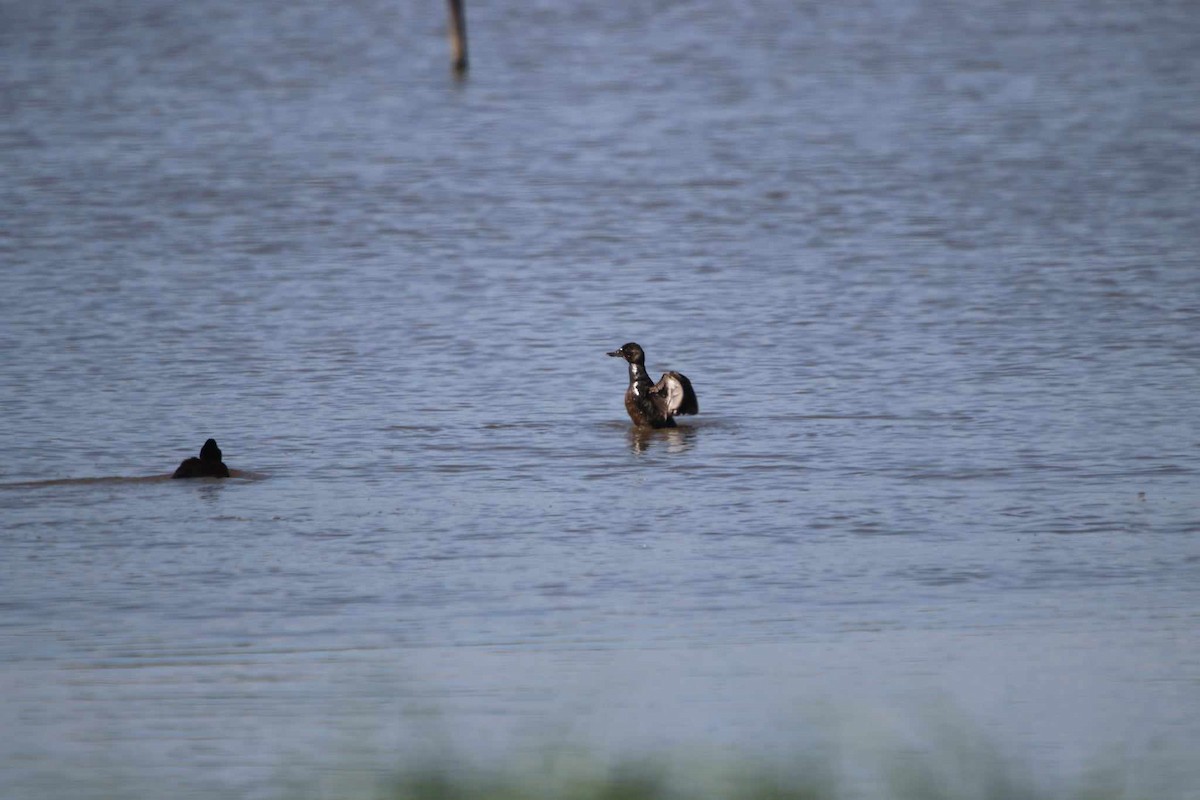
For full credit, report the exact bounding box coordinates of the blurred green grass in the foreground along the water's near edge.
[14,717,1176,800]
